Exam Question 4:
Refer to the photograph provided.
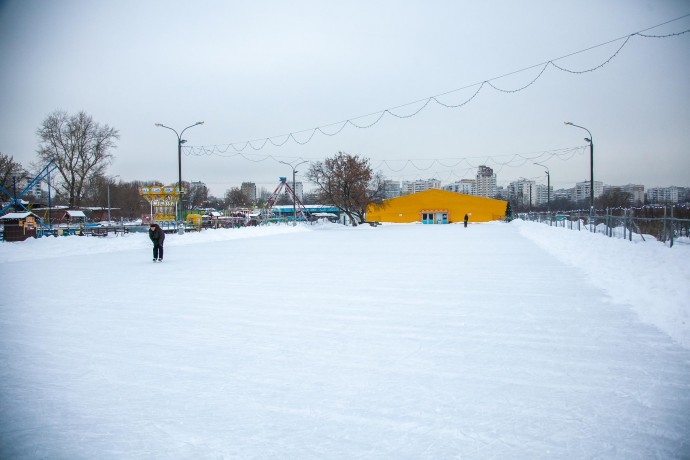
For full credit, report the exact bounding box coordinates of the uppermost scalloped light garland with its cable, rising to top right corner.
[183,14,690,154]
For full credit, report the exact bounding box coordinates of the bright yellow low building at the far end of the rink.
[367,190,508,224]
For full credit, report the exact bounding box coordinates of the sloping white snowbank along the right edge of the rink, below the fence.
[511,220,690,348]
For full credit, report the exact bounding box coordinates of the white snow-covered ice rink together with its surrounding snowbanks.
[0,222,690,459]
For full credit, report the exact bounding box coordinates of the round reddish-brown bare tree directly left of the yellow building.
[306,152,383,225]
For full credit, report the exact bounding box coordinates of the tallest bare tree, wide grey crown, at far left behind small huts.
[36,111,120,206]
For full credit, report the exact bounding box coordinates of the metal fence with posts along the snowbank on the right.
[518,208,690,247]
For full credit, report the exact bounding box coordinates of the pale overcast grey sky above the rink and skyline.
[0,0,690,196]
